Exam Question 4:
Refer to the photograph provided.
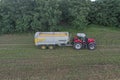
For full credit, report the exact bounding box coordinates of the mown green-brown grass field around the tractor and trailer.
[0,26,120,80]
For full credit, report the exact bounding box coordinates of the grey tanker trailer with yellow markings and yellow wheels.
[35,32,70,49]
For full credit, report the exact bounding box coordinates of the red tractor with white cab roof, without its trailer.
[72,33,96,50]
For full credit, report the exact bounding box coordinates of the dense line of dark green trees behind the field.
[0,0,120,33]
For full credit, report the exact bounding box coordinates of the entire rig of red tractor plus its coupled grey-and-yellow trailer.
[34,32,96,50]
